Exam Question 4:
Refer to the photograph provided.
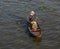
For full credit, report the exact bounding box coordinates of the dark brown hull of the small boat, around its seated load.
[27,21,42,38]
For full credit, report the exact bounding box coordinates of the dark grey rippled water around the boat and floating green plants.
[0,0,60,49]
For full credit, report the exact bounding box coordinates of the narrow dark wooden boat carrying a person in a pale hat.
[27,21,41,38]
